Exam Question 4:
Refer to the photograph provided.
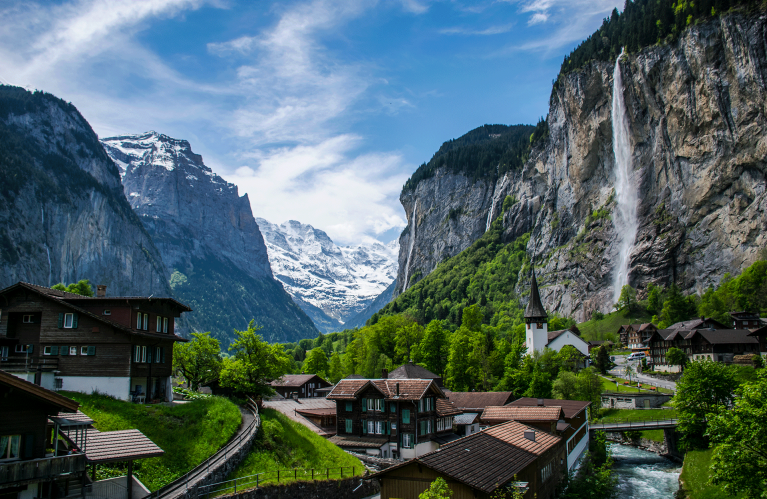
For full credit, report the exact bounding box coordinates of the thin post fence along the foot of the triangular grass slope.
[198,466,364,498]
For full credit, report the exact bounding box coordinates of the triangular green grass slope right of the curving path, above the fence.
[227,409,364,480]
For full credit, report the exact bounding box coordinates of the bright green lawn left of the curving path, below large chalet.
[61,392,242,491]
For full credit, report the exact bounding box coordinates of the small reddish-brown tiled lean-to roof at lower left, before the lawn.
[67,429,165,463]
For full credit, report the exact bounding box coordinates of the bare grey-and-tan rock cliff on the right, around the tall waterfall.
[398,13,767,320]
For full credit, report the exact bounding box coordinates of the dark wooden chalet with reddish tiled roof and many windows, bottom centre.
[327,379,460,459]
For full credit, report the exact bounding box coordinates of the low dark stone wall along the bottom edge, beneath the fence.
[216,477,381,499]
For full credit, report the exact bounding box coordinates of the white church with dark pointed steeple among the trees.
[525,269,589,365]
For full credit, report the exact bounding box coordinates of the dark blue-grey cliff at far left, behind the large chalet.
[0,86,172,296]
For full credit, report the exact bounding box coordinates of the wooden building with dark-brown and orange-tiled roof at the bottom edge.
[372,421,566,499]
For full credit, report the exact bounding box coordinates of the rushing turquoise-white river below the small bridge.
[610,444,682,499]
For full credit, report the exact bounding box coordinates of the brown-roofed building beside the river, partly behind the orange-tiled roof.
[506,397,591,470]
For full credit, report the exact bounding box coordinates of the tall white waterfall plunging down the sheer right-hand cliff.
[612,50,639,303]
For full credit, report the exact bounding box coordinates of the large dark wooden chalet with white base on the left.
[0,282,191,402]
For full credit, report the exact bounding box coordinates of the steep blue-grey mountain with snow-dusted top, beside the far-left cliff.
[101,132,319,344]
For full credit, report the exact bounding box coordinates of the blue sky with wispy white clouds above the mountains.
[0,0,623,245]
